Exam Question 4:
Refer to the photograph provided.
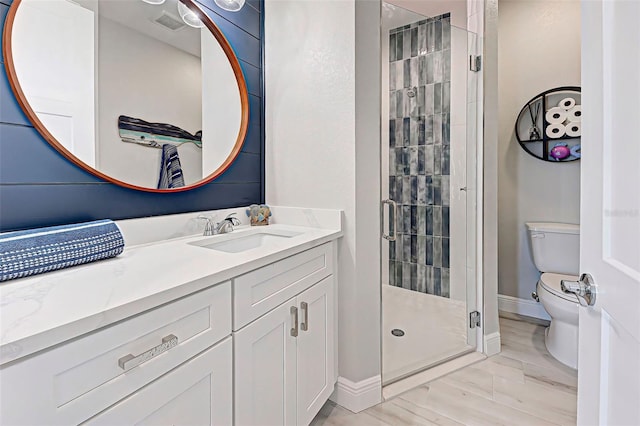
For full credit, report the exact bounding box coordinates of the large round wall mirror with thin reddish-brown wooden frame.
[3,0,249,192]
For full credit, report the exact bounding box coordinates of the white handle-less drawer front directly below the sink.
[233,243,333,331]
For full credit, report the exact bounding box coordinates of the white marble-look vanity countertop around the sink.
[0,210,342,365]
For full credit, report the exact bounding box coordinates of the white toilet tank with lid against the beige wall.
[525,222,580,275]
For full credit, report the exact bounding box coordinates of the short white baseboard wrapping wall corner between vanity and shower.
[329,376,382,413]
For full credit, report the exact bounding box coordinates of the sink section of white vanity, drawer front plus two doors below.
[234,244,337,426]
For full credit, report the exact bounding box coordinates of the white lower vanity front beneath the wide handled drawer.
[87,337,233,426]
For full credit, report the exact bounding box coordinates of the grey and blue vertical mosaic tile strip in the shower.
[389,14,451,297]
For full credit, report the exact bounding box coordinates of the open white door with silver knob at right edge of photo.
[578,0,640,425]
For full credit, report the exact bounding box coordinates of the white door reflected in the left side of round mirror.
[11,0,96,166]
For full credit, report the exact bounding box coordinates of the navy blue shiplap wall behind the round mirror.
[0,0,264,231]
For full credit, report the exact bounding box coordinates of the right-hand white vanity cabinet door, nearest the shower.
[296,276,334,425]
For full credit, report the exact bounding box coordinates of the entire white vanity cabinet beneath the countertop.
[0,241,337,426]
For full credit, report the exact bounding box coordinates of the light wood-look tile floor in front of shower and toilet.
[311,318,577,426]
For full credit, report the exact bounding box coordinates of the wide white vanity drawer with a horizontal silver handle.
[0,282,231,424]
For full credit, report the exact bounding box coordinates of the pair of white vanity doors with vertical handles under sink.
[234,276,334,426]
